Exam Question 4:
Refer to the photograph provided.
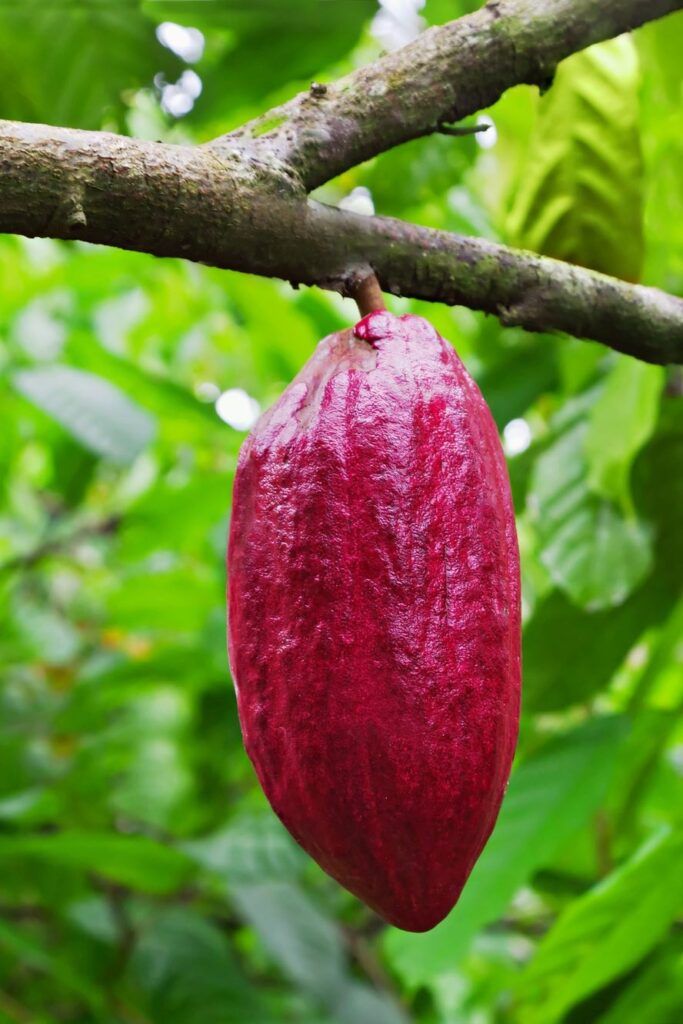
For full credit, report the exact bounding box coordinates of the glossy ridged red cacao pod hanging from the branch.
[228,312,520,932]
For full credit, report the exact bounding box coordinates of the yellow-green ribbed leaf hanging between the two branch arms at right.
[509,35,643,281]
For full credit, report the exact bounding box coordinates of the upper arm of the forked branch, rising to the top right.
[218,0,683,191]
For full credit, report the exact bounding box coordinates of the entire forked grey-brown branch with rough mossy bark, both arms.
[0,0,683,362]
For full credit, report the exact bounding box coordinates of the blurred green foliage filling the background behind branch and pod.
[0,0,683,1024]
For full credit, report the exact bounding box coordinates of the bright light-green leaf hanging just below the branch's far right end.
[584,355,666,510]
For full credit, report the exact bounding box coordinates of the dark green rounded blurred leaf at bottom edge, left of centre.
[129,907,272,1024]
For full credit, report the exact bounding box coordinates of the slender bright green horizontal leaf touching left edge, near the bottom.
[0,829,193,893]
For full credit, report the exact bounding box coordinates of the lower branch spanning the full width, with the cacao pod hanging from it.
[0,121,683,364]
